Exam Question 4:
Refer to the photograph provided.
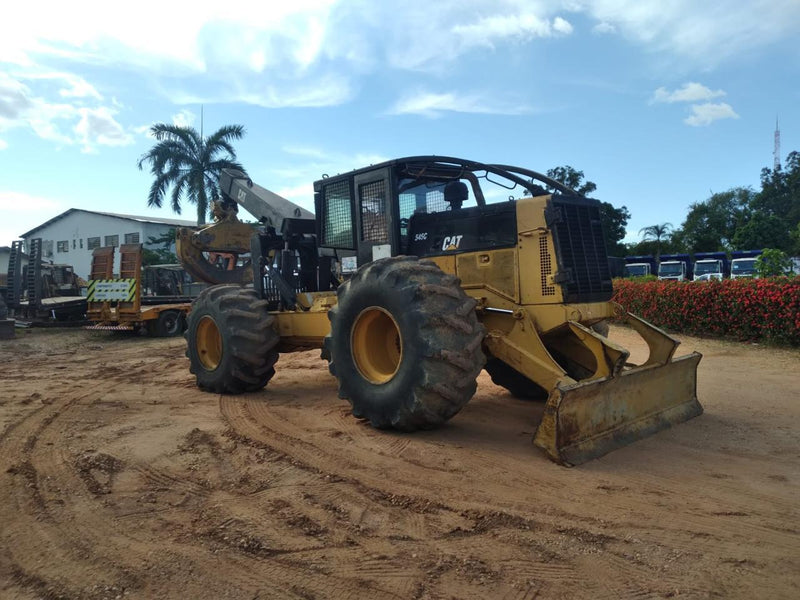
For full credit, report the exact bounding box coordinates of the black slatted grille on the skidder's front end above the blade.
[546,195,613,302]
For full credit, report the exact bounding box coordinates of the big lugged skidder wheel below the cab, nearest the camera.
[323,256,485,431]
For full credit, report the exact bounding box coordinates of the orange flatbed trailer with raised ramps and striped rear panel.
[86,244,192,337]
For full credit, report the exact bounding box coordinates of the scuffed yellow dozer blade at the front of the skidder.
[534,352,703,465]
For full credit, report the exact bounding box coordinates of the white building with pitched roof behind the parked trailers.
[20,208,196,279]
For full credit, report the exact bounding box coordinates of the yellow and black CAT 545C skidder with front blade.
[179,156,702,464]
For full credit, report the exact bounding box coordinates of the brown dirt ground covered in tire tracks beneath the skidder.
[0,327,800,600]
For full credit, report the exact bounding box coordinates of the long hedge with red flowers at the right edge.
[614,277,800,346]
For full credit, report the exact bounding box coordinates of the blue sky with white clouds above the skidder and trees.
[0,0,800,245]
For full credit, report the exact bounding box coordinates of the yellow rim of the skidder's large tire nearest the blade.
[350,306,403,384]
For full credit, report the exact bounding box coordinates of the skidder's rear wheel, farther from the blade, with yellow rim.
[185,285,280,394]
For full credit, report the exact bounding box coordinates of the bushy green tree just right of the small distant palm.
[675,187,755,253]
